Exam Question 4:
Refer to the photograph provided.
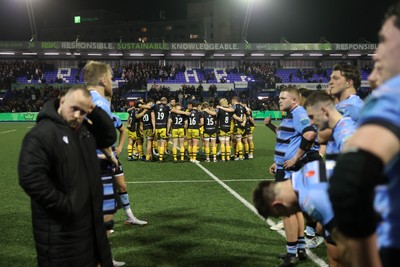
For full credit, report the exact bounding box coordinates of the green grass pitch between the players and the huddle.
[0,123,326,266]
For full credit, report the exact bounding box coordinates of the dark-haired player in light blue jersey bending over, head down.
[253,164,342,267]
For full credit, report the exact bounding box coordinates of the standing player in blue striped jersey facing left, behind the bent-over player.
[267,87,321,266]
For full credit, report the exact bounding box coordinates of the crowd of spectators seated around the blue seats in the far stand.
[0,61,372,112]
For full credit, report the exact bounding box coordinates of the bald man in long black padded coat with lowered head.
[18,88,116,267]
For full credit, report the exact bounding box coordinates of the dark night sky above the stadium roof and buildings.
[0,0,395,43]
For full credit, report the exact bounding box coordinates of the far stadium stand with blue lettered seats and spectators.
[0,61,371,112]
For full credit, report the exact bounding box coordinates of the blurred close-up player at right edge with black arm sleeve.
[329,2,400,266]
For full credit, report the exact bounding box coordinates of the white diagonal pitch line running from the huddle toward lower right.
[196,163,328,267]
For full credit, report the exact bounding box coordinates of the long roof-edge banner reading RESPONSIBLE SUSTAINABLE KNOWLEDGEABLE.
[0,41,378,53]
